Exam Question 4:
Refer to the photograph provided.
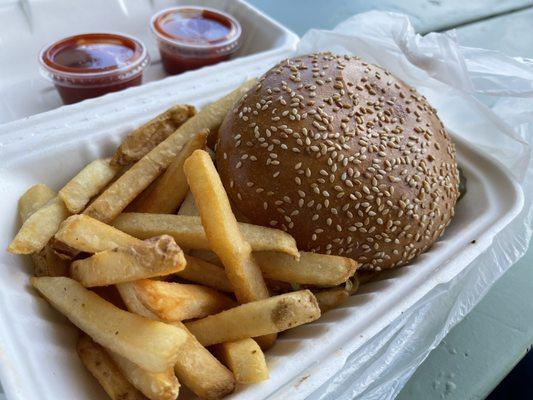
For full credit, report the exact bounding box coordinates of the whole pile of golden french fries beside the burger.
[8,81,357,400]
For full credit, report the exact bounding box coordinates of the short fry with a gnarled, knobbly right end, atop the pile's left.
[70,235,186,287]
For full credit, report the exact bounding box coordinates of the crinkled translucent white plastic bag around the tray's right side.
[298,12,533,400]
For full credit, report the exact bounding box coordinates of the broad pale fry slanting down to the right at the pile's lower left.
[31,277,186,372]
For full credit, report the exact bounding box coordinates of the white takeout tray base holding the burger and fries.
[0,46,523,400]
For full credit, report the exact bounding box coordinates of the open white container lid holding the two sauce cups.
[0,0,298,123]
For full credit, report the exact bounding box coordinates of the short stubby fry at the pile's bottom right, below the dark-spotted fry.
[215,338,268,384]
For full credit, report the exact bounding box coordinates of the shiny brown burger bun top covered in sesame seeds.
[216,53,459,270]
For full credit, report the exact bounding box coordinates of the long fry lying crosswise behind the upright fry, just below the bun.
[113,213,299,257]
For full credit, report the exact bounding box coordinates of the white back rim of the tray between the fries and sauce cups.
[0,49,292,161]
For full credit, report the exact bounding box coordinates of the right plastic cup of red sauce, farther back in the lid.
[150,6,242,75]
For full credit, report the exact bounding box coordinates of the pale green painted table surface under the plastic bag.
[249,0,533,400]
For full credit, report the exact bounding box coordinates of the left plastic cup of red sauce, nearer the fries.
[39,33,150,104]
